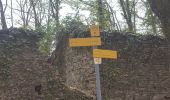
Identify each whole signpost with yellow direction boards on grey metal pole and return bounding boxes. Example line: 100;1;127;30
69;25;117;100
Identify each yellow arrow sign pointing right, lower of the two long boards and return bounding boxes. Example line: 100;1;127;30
93;49;117;59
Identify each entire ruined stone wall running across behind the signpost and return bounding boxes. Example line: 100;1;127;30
0;29;170;100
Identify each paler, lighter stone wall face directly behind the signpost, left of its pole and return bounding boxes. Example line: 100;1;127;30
65;47;95;96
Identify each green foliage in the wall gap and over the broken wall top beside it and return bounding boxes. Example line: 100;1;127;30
39;16;88;54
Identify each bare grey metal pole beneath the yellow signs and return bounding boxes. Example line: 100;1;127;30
95;64;102;100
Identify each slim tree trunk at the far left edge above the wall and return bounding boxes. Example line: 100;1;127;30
0;0;7;29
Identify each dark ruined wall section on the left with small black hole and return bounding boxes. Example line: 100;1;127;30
0;28;93;100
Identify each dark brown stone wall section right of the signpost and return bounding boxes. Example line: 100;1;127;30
102;34;170;100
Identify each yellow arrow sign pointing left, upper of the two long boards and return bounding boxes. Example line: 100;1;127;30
69;37;101;47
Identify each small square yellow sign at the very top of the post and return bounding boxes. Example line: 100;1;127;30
90;25;100;36
